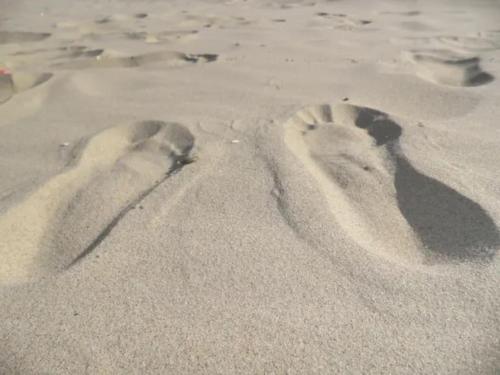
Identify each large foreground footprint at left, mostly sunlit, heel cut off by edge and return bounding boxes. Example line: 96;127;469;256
0;121;194;284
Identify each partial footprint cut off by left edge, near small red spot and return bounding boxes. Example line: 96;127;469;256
0;70;52;104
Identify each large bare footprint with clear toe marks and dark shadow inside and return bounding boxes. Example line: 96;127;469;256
285;104;500;264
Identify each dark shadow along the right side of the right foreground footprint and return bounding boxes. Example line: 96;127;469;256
356;108;500;261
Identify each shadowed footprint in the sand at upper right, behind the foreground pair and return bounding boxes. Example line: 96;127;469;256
406;50;494;87
